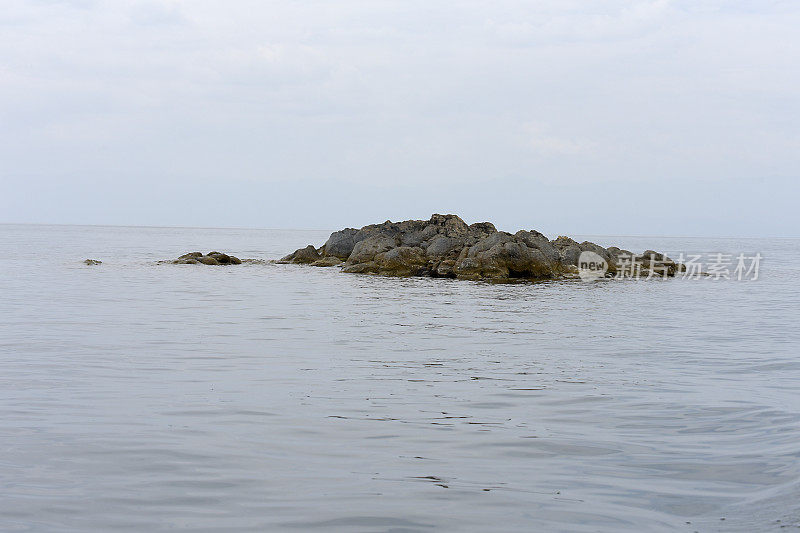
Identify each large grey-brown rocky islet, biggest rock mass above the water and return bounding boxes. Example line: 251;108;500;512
279;215;682;281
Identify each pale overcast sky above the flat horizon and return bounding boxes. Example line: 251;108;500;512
0;0;800;236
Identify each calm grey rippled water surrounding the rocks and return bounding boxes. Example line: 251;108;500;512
0;225;800;532
